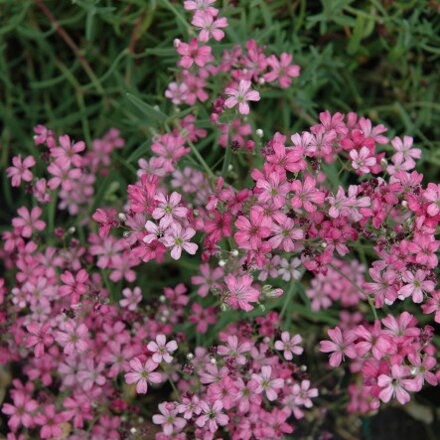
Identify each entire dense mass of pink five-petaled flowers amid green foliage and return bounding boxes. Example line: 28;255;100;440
0;0;440;440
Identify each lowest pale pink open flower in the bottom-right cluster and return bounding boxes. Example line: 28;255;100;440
377;365;420;405
